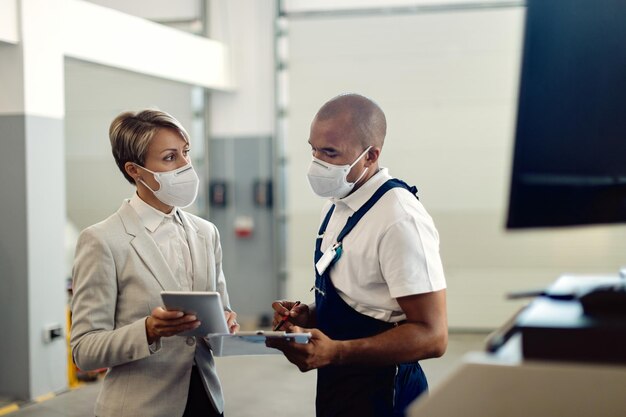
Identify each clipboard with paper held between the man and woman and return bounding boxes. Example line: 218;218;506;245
207;330;311;356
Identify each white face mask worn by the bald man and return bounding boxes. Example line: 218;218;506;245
307;146;371;198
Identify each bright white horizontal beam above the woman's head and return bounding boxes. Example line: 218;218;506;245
62;0;232;89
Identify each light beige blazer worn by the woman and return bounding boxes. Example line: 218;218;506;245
70;201;230;417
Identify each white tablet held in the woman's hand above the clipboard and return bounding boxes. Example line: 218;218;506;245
161;291;228;336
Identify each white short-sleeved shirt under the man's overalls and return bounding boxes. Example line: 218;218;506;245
321;168;446;322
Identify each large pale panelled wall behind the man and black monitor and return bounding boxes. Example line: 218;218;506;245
287;7;626;329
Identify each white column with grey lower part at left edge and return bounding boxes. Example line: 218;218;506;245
0;0;67;400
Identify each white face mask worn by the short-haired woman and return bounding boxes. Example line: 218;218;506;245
138;162;200;207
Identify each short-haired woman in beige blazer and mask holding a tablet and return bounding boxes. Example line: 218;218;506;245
71;110;239;417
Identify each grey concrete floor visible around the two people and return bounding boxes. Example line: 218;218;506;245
0;333;487;417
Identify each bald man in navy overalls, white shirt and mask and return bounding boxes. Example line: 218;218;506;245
267;94;447;417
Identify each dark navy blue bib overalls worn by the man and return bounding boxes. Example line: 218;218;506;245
314;179;428;417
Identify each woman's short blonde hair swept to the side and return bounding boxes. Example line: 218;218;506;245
109;109;189;185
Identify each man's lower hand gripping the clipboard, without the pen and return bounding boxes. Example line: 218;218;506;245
265;326;341;372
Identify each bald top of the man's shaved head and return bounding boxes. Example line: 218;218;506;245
313;94;387;148
